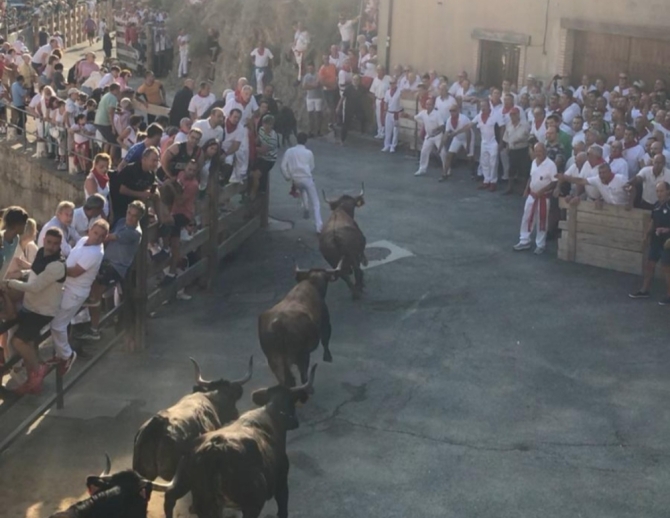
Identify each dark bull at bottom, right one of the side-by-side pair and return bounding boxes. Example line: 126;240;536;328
165;365;316;518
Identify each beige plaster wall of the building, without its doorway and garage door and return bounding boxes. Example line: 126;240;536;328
379;0;670;86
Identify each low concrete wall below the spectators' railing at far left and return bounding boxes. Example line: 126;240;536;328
0;142;84;224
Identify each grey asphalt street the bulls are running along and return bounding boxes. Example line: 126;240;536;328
0;137;670;518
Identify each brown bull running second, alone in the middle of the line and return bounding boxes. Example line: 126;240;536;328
258;265;341;387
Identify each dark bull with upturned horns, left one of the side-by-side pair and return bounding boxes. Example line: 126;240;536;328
133;356;254;480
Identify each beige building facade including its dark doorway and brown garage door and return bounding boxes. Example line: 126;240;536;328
378;0;670;88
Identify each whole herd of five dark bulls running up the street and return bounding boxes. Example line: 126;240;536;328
52;186;367;518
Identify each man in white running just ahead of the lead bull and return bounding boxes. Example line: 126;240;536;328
281;133;323;234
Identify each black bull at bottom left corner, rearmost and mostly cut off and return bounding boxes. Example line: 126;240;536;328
51;455;169;518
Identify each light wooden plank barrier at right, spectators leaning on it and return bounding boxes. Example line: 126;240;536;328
558;199;651;275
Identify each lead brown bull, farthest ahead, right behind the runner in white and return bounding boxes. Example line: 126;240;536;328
319;184;368;299
